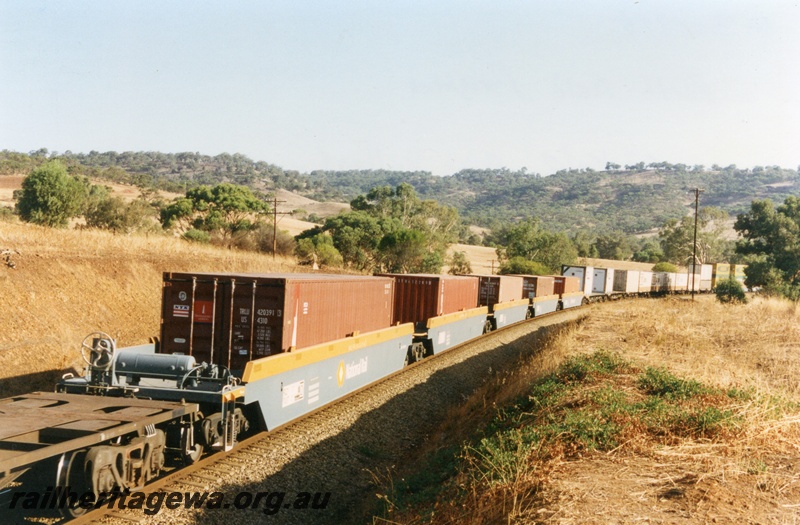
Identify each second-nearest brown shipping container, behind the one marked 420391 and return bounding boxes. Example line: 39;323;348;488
378;273;478;324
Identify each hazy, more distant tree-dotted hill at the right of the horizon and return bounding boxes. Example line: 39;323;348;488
310;163;800;233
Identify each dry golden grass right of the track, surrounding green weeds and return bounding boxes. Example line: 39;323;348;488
378;296;800;524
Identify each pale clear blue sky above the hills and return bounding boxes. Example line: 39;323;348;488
0;0;800;175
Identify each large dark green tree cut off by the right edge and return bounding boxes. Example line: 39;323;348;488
733;197;800;289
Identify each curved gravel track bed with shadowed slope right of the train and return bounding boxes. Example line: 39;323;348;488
51;309;587;525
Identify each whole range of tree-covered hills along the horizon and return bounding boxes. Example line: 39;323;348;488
0;150;800;234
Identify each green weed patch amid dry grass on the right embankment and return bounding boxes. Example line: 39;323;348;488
376;351;746;521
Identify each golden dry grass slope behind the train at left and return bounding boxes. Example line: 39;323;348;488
0;217;307;395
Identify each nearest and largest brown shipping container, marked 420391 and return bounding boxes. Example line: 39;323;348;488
161;273;394;370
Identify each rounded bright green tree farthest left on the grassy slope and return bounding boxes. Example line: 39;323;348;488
17;160;87;228
